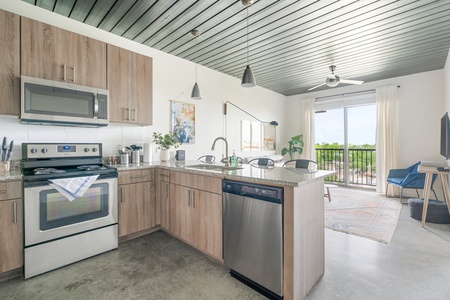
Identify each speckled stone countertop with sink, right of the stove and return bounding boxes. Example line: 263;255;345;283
114;161;336;187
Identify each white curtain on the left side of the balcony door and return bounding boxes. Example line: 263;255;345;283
300;98;316;161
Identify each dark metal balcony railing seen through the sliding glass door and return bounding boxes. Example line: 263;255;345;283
316;148;376;186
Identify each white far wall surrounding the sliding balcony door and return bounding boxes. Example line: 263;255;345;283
283;69;444;167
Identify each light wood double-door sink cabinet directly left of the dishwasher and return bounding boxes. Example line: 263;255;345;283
170;172;222;260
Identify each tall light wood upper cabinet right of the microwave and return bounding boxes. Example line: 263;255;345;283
107;45;153;125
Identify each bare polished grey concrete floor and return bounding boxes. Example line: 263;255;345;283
0;205;450;300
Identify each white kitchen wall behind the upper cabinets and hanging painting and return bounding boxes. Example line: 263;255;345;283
0;0;286;160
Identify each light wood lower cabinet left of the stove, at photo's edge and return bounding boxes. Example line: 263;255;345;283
0;181;23;273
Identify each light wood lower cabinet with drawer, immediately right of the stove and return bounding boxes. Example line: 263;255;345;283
119;169;156;237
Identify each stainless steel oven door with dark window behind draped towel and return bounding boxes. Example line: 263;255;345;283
24;178;118;246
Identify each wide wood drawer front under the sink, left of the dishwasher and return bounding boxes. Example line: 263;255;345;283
170;171;222;194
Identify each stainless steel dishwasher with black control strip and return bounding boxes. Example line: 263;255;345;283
222;180;283;299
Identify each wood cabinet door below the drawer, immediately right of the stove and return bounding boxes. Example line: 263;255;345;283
119;181;155;237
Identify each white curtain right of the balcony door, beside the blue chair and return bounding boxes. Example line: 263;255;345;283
376;85;398;194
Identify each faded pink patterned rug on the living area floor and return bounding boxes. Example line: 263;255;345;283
324;187;402;244
